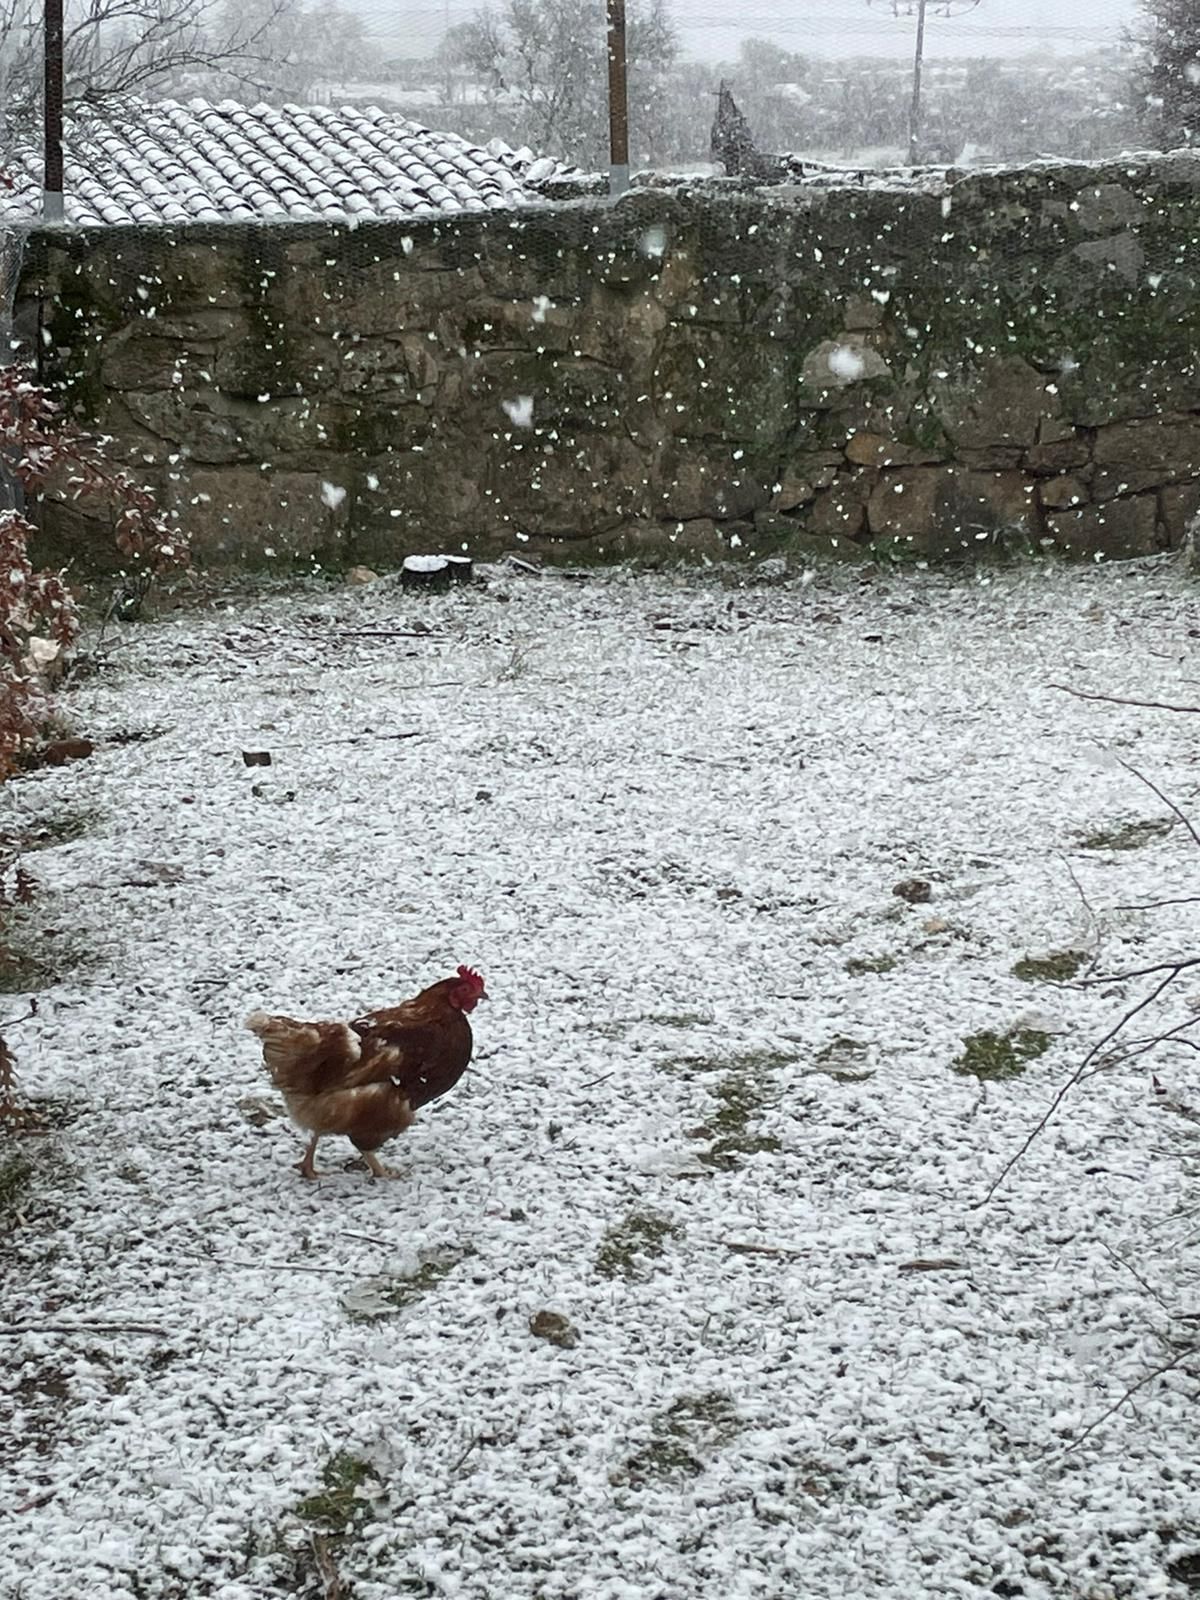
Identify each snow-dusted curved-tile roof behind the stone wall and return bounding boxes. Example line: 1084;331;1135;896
0;99;558;227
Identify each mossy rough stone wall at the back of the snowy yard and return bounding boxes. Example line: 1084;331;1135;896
19;155;1200;563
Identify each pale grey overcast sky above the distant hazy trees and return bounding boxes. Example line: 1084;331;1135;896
347;0;1138;59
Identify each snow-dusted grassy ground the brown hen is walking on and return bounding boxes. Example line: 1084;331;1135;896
0;562;1200;1600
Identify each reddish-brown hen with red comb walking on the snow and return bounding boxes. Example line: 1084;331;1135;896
246;966;488;1178
